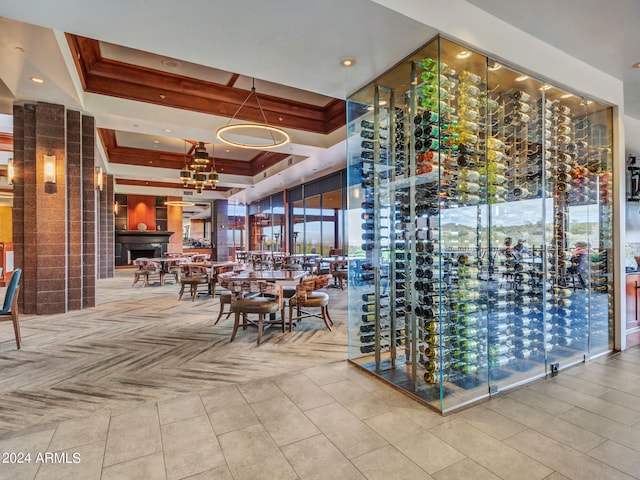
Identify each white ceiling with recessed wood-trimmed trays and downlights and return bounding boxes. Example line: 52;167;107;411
0;0;640;202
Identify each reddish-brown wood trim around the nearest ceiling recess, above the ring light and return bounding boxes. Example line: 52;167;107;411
67;34;346;135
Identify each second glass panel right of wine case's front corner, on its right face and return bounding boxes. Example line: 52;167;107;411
486;61;551;391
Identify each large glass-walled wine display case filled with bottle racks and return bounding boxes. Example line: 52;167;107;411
347;37;613;412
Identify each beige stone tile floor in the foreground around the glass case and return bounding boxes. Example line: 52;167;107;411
0;347;640;480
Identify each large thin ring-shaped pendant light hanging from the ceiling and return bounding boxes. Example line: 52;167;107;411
216;78;290;150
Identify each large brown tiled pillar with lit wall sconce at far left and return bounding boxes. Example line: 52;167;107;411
13;103;95;314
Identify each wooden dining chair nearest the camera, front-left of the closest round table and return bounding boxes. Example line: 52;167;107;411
229;280;285;345
